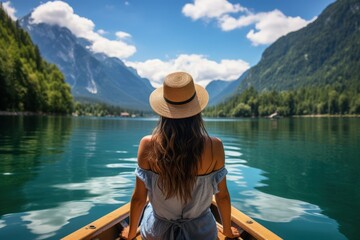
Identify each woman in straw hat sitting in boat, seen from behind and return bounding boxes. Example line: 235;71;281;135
122;72;239;239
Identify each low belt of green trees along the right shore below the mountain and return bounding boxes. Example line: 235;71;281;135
205;85;360;117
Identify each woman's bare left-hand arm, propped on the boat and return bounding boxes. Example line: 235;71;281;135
122;136;151;239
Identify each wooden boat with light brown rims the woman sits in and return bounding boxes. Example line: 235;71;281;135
62;199;281;240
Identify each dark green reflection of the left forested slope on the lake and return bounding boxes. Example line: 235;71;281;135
0;116;72;216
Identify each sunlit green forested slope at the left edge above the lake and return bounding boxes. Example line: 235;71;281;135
0;5;73;113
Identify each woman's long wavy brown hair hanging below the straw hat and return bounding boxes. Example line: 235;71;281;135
150;113;209;203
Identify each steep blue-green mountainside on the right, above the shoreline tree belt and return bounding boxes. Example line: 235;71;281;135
240;0;360;91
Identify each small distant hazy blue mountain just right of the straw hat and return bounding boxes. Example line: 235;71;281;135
206;71;247;106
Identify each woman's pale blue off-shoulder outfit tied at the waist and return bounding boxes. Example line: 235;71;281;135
135;167;227;240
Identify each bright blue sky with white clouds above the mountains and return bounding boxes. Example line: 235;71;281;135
3;0;334;86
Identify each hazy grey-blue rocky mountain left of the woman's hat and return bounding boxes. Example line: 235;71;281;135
19;14;153;110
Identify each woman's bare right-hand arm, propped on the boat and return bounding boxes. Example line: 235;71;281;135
214;139;239;238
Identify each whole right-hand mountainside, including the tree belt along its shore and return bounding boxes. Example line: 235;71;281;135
207;0;360;116
